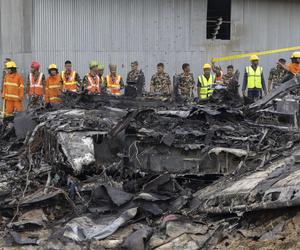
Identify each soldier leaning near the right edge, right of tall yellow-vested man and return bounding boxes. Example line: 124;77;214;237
268;58;288;92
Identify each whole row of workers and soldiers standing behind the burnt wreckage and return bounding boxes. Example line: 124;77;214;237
2;52;300;117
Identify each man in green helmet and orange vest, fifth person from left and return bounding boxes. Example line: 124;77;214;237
83;61;101;94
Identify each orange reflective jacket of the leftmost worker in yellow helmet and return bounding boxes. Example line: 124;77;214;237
2;73;24;101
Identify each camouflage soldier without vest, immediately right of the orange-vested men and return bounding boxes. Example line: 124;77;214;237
126;61;145;96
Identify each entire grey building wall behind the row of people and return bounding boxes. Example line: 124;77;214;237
0;0;300;90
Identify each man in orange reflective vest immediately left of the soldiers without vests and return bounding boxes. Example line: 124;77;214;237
105;64;124;96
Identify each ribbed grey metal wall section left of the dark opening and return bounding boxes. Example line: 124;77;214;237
33;0;205;87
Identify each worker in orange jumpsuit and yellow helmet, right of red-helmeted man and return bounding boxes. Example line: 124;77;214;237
45;64;62;106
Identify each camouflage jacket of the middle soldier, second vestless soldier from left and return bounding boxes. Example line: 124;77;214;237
150;72;171;95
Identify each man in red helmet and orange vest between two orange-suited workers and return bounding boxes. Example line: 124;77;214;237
27;61;45;108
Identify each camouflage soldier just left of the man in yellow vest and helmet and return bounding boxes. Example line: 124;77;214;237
174;63;195;99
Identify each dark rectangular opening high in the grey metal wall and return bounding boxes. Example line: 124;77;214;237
206;0;231;40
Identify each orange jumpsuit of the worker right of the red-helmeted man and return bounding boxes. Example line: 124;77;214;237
45;74;62;103
